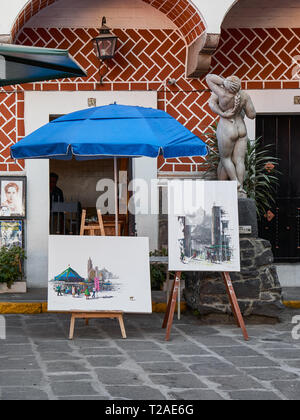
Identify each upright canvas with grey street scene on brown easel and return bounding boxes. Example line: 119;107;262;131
168;180;240;272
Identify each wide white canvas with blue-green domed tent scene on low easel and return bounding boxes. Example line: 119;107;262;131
48;235;152;313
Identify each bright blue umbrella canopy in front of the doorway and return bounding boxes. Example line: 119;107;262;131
11;104;207;160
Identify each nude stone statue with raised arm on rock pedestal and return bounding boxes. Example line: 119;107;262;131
206;74;256;197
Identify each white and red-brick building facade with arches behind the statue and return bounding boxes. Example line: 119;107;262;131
0;0;300;287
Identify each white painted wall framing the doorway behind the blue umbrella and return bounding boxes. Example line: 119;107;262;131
25;92;158;288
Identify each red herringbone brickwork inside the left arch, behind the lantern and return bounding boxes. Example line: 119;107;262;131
17;28;186;85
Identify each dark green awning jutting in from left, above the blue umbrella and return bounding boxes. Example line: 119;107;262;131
0;44;87;86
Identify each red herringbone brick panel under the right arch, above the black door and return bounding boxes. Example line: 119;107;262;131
212;28;300;89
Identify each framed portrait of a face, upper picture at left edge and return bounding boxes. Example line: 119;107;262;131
0;176;26;219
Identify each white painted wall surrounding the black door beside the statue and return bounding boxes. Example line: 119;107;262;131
246;90;300;287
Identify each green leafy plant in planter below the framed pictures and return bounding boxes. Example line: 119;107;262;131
0;246;25;288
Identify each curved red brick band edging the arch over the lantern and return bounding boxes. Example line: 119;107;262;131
11;0;205;45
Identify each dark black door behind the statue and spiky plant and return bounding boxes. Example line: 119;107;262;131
256;115;300;262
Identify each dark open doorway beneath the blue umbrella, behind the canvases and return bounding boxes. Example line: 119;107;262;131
49;115;135;236
